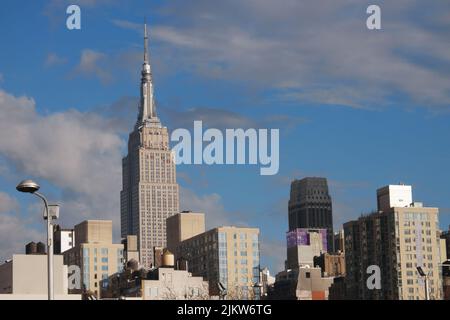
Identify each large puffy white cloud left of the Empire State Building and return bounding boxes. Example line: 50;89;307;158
0;91;124;238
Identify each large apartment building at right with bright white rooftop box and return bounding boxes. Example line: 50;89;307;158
344;186;446;300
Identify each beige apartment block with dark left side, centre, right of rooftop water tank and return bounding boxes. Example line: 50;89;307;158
176;226;260;299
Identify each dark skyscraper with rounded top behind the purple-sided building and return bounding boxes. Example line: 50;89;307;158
289;177;334;252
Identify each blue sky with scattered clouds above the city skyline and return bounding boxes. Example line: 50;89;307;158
0;0;450;273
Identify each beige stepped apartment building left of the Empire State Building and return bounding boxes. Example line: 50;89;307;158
64;220;124;297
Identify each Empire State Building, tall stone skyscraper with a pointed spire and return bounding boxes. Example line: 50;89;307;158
120;25;179;268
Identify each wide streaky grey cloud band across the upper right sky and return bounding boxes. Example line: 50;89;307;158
110;0;450;110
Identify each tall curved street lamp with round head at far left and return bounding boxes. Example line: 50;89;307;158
16;180;54;300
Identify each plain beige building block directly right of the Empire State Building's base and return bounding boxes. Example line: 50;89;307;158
166;211;205;258
